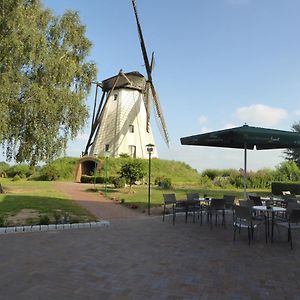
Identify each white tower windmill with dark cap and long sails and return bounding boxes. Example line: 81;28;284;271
83;0;169;158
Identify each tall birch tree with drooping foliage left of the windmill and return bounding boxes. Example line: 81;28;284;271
0;0;96;165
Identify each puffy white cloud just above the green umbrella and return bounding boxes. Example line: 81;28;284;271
235;104;288;126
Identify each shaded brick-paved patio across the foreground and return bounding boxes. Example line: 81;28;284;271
0;212;300;300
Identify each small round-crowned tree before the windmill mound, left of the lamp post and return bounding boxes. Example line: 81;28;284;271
119;159;145;192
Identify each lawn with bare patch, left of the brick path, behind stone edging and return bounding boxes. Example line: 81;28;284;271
0;179;95;225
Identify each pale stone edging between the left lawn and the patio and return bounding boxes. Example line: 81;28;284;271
0;221;110;234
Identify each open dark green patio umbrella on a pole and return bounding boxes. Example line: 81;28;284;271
180;125;300;198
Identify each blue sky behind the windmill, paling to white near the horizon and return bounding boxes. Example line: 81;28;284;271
43;0;300;171
